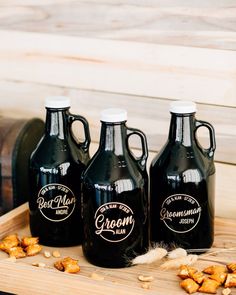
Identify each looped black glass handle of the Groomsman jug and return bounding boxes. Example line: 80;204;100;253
195;120;216;158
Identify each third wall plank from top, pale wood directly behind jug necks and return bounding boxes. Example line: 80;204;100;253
0;80;236;164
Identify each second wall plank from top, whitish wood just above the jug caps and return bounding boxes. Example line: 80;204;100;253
0;30;236;107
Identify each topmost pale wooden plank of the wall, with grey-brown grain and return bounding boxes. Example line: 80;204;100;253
0;0;236;50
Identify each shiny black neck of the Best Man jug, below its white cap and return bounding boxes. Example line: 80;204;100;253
45;108;69;139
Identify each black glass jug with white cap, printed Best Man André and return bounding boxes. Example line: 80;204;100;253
29;96;90;247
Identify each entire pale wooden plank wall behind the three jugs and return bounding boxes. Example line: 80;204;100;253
0;0;236;218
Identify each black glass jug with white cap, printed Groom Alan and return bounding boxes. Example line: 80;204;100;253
82;109;148;268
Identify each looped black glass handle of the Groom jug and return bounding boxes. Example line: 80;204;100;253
127;127;148;171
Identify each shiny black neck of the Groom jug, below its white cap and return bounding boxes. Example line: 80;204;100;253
99;122;126;155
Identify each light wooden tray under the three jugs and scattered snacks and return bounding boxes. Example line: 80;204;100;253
0;204;236;295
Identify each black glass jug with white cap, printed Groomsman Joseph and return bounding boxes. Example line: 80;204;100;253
150;101;216;250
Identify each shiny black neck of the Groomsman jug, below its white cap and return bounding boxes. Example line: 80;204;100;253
169;113;195;146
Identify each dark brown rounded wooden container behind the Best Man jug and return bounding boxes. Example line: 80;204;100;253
0;117;44;215
